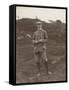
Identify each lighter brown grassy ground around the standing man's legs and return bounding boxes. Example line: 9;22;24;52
16;38;66;83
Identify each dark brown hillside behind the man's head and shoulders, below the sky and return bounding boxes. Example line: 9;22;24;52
16;18;65;43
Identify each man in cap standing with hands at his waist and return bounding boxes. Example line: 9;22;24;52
33;21;49;76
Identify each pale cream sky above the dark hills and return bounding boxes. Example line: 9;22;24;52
16;6;66;23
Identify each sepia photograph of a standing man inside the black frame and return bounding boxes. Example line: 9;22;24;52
16;6;67;84
